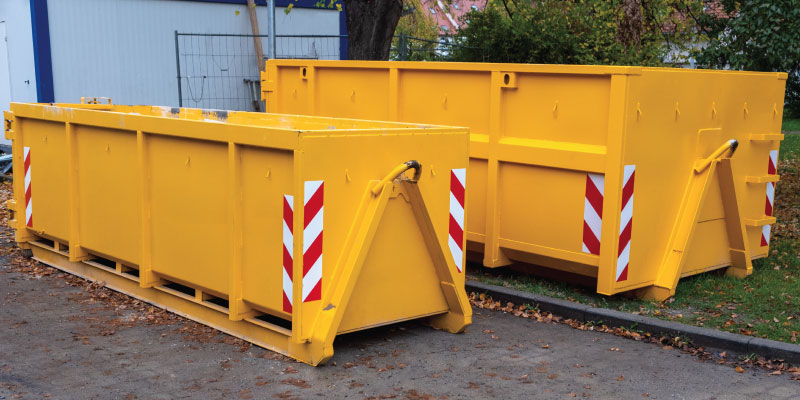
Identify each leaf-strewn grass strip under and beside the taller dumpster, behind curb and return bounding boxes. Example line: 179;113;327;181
469;134;800;343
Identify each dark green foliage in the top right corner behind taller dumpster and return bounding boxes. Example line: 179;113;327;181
697;0;800;117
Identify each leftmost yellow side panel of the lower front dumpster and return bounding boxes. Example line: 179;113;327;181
17;118;69;243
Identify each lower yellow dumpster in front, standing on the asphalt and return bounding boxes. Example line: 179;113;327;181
5;103;471;365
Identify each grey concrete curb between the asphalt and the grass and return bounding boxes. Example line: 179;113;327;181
466;281;800;364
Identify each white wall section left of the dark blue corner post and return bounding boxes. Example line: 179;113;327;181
0;0;36;106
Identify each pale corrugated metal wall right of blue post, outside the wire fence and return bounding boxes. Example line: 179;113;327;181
48;0;339;106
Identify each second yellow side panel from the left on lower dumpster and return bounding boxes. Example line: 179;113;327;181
72;125;142;265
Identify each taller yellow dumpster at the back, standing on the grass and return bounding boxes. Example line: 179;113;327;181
261;60;786;299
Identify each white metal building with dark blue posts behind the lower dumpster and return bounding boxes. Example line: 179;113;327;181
0;0;347;134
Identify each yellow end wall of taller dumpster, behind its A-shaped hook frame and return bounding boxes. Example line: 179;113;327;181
622;69;785;286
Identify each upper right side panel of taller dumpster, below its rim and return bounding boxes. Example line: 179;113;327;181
500;73;611;147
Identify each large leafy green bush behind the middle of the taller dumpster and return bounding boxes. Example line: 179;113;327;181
453;0;699;65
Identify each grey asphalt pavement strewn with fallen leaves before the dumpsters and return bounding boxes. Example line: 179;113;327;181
0;263;800;399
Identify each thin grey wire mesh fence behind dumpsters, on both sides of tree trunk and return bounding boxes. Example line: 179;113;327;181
175;31;476;111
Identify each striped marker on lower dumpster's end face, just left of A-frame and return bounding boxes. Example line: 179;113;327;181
303;181;325;303
